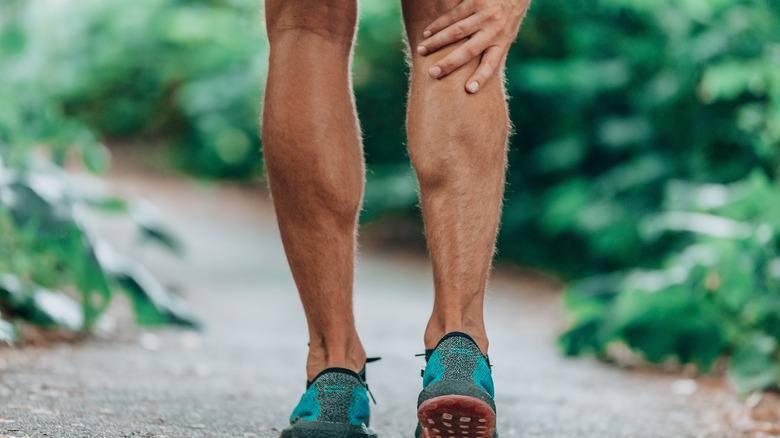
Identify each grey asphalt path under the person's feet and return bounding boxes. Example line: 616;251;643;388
0;161;762;438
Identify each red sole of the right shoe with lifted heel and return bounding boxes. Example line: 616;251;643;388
417;395;496;438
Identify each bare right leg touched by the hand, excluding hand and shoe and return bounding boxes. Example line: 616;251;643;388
403;0;509;353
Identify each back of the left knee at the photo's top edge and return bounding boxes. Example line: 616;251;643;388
266;0;357;48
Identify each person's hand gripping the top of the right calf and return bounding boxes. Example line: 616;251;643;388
417;0;531;93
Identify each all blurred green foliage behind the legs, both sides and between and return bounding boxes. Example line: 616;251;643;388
0;0;780;404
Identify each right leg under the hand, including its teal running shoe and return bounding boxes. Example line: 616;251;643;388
403;4;509;438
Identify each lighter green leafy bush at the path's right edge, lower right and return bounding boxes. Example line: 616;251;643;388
561;171;780;392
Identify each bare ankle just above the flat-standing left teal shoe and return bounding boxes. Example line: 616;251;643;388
306;333;366;381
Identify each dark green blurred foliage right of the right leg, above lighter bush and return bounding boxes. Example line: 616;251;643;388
500;0;780;275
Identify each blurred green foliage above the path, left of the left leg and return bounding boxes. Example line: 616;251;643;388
6;0;267;178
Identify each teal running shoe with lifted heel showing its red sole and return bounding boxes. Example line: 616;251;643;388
415;332;498;438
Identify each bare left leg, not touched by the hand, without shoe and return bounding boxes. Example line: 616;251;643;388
262;0;365;380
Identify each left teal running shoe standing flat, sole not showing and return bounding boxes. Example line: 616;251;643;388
281;368;376;438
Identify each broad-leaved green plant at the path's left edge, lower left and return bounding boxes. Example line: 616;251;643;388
0;159;197;340
